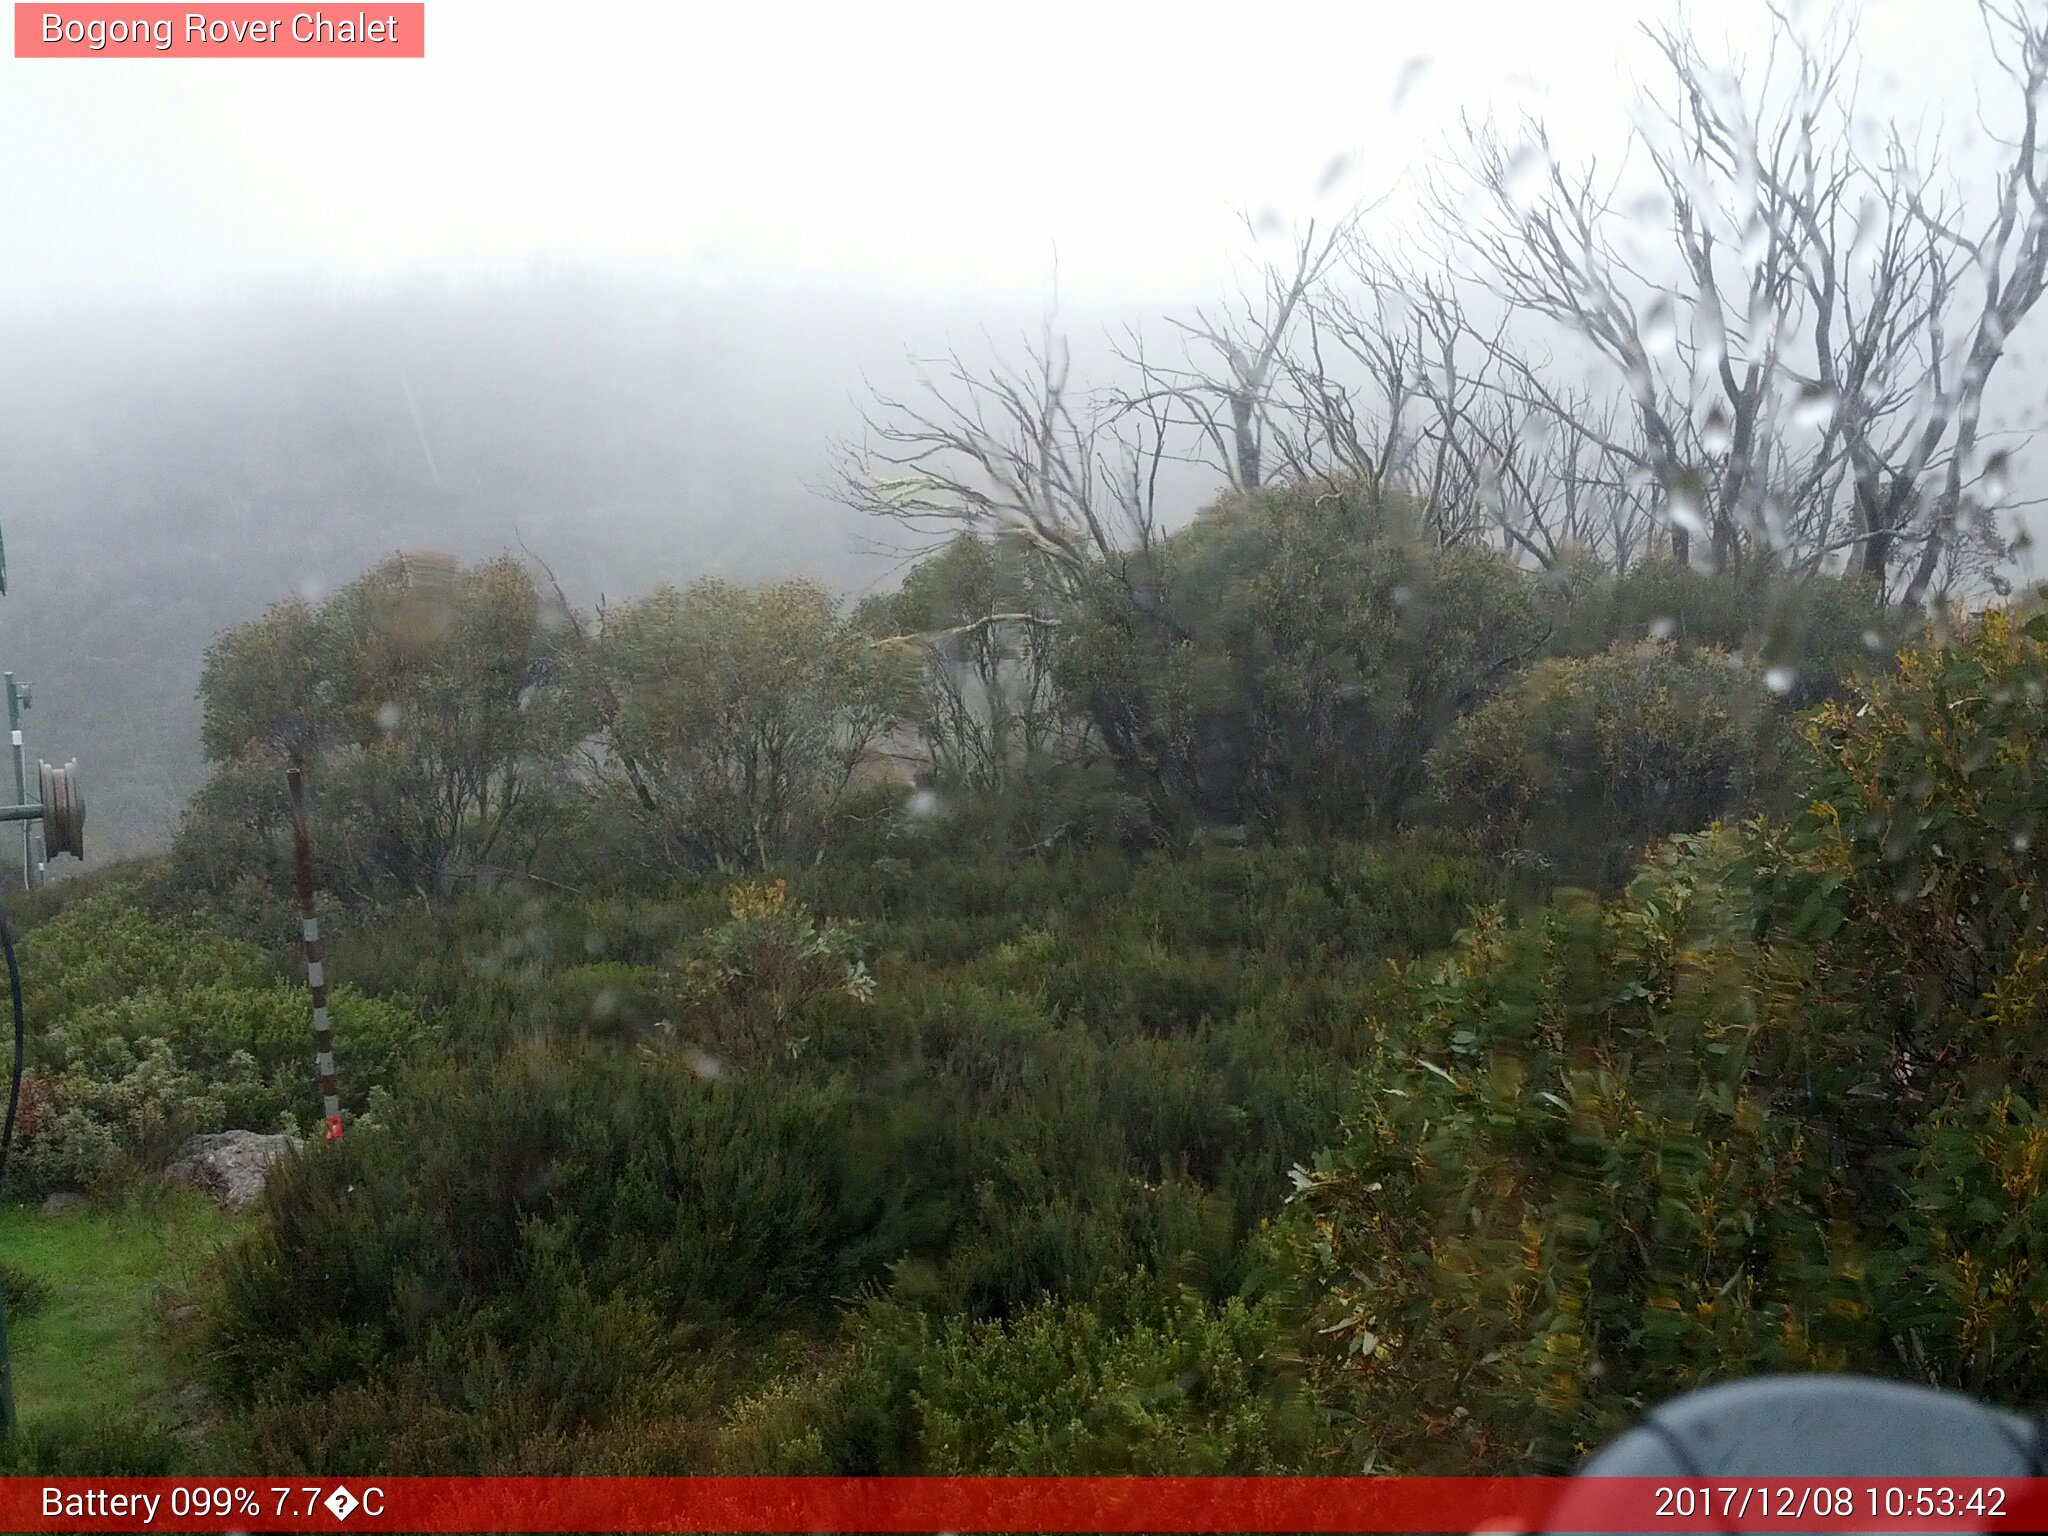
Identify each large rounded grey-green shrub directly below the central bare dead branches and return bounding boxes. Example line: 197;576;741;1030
1167;483;1546;838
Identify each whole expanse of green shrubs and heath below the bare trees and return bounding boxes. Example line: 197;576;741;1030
12;456;2048;1475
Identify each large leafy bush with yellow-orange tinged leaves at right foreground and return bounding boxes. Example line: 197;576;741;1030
1282;612;2048;1470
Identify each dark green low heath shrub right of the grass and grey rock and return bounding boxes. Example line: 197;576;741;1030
201;1044;937;1464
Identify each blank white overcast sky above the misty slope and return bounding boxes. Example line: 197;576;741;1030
0;0;2007;309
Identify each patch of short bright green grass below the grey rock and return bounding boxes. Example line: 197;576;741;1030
0;1190;238;1440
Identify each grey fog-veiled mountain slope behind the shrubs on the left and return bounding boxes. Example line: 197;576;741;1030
0;281;991;860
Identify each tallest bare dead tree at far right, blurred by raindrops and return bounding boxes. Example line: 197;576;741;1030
1438;0;2048;604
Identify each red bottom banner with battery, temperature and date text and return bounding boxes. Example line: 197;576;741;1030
12;1477;2048;1536
